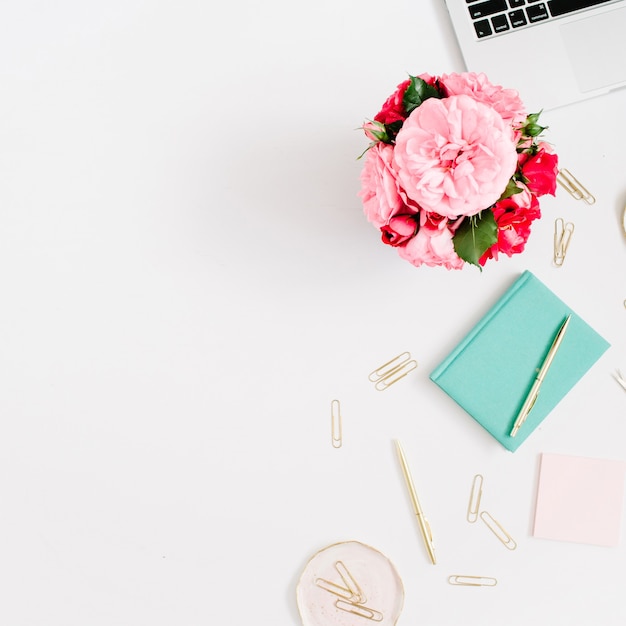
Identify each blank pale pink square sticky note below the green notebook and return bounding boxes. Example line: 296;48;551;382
533;454;626;546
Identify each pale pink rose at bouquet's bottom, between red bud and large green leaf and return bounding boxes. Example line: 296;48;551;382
397;212;465;270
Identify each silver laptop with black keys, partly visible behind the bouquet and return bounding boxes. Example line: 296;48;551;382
445;0;626;112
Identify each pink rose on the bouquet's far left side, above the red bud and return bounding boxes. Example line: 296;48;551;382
359;143;414;228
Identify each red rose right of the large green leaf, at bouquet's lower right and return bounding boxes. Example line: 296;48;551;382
478;195;541;265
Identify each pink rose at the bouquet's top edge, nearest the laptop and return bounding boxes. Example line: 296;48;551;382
440;72;526;126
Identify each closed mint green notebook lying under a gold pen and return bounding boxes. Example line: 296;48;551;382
430;271;609;451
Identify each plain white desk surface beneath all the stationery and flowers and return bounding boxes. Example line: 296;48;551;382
0;0;626;626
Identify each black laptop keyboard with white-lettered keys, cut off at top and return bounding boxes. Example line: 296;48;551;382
466;0;615;39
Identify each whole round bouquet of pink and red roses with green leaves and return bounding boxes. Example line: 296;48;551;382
359;73;558;269
